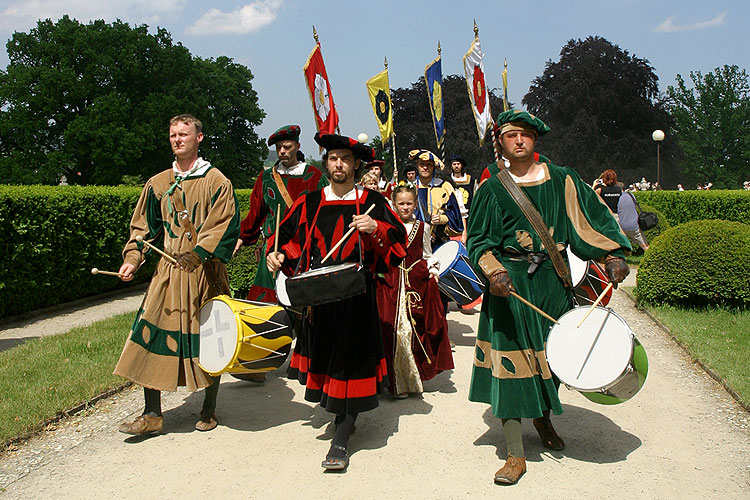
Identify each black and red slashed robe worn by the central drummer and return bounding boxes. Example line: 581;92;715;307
279;187;405;414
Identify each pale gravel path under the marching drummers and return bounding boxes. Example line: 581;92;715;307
0;280;750;500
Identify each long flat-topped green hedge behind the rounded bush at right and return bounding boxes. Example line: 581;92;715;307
635;190;750;226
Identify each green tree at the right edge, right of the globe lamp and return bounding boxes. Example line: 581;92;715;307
667;65;750;188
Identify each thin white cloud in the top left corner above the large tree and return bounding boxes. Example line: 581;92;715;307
0;0;186;30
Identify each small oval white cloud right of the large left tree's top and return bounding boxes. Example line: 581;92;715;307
188;0;281;35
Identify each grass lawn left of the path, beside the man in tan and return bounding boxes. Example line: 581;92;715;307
0;312;135;443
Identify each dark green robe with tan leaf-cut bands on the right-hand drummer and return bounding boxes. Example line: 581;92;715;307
467;163;630;418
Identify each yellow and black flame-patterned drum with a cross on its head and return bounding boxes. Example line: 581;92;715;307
198;295;292;375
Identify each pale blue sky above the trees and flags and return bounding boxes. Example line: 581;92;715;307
0;0;750;156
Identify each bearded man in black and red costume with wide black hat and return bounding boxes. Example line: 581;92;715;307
266;133;406;470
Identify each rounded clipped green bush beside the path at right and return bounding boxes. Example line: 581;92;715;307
635;220;750;308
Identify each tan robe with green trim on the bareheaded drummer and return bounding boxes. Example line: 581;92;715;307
114;159;240;391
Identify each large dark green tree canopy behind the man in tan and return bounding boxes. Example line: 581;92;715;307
0;16;267;187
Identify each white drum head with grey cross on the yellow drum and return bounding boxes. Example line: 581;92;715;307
198;299;238;374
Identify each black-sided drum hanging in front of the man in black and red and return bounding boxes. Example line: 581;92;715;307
284;262;367;307
